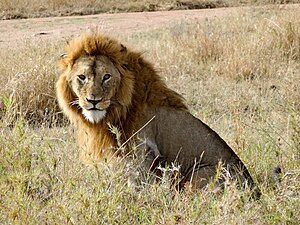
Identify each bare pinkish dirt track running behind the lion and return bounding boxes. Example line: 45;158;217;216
0;8;245;49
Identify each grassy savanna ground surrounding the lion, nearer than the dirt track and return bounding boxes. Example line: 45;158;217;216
0;0;300;224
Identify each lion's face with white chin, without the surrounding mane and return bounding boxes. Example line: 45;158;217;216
69;56;121;123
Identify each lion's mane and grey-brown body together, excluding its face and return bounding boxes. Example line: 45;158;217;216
56;32;253;195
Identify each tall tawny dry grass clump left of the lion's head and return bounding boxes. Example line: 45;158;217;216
0;43;62;126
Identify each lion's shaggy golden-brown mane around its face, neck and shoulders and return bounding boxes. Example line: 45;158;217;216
56;32;187;158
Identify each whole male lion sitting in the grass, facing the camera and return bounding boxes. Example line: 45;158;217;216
56;32;260;195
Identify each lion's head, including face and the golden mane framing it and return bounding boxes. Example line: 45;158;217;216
57;32;133;124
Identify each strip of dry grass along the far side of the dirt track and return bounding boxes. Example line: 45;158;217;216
0;0;299;19
